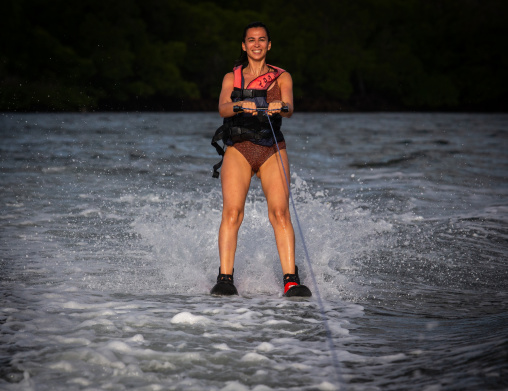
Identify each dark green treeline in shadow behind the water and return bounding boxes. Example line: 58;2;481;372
0;0;508;111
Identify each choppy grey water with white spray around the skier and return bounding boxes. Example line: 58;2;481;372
0;113;508;391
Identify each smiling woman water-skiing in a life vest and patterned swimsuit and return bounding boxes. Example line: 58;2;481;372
211;22;310;296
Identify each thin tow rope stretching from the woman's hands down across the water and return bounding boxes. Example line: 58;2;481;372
265;110;343;384
